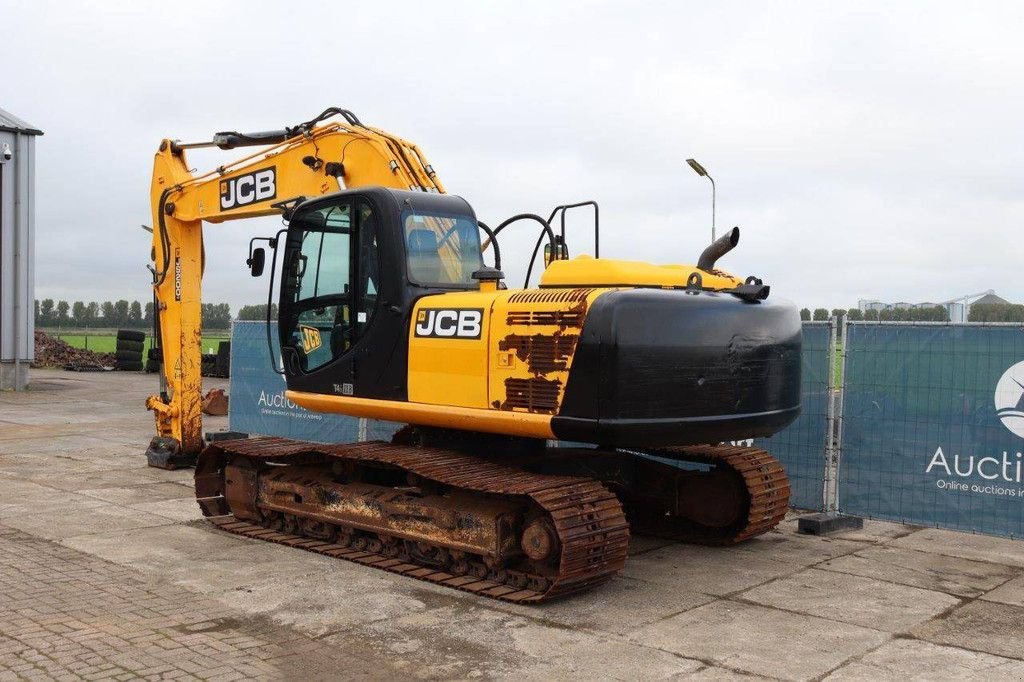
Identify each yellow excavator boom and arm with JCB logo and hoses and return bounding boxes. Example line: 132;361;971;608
145;109;444;468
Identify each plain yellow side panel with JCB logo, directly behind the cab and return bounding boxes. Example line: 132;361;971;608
409;292;500;408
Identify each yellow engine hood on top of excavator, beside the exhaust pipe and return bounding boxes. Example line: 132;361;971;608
541;256;743;289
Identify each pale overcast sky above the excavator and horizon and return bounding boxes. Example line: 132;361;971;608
0;0;1024;309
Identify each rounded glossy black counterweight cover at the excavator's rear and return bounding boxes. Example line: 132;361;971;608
551;289;801;446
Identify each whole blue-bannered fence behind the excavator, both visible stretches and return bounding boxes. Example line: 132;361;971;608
230;321;1024;538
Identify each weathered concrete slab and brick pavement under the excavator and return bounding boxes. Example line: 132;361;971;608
0;370;1024;680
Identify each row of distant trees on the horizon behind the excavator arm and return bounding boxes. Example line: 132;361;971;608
36;298;234;329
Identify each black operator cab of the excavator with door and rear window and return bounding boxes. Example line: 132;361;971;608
279;187;483;399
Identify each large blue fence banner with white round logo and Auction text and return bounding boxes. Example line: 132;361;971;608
840;324;1024;538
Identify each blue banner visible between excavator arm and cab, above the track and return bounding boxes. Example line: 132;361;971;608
228;322;400;442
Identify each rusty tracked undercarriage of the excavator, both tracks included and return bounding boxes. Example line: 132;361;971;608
196;427;790;603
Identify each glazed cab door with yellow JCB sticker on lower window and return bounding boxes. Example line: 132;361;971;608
280;197;380;395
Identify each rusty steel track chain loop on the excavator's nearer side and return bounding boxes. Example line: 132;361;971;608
196;437;630;603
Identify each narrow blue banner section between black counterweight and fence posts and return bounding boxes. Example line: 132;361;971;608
754;323;831;509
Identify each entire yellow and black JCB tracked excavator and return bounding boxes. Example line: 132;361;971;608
146;108;801;604
